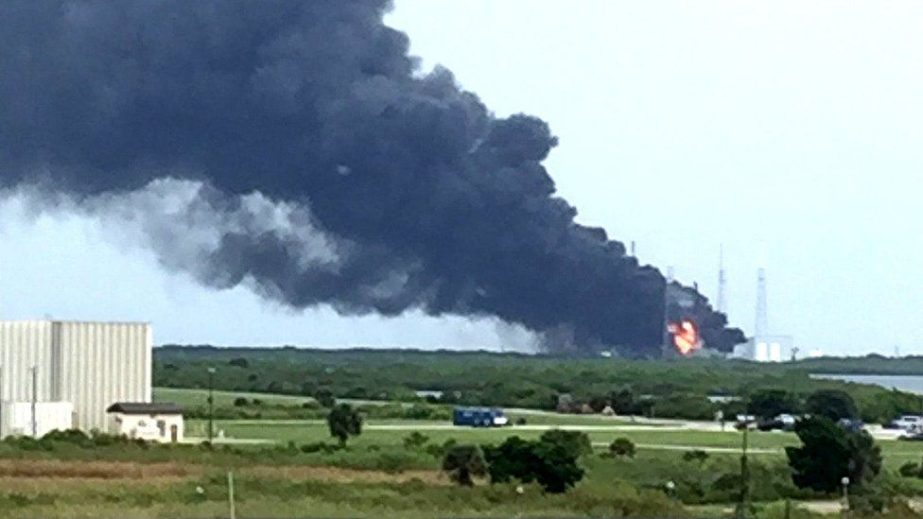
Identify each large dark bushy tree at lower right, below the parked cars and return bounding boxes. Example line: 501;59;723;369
785;417;881;493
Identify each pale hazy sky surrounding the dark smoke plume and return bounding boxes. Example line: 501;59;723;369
0;0;923;355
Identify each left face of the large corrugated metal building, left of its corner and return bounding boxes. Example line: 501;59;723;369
0;321;55;402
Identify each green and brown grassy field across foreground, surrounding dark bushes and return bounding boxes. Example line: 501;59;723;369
0;389;923;519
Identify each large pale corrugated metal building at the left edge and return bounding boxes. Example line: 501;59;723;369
0;320;153;437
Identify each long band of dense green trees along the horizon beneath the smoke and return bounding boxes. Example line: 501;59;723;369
154;346;923;422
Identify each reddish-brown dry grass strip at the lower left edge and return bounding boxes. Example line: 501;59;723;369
0;460;202;479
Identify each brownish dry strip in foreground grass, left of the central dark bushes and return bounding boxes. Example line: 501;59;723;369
241;466;451;485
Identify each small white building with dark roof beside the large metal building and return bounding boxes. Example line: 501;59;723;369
106;402;184;443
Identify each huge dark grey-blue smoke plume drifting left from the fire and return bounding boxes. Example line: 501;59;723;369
0;0;742;355
